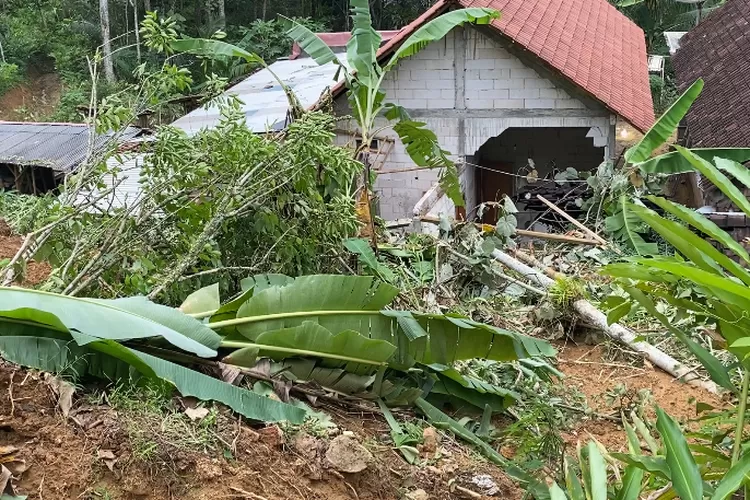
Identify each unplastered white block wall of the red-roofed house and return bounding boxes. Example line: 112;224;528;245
335;28;609;220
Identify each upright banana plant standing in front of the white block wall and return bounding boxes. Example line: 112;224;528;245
287;0;500;206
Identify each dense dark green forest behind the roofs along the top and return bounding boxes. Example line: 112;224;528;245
0;0;722;121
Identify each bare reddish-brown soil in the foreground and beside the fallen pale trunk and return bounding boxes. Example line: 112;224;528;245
0;344;722;500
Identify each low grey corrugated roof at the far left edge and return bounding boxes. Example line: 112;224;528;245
0;122;140;173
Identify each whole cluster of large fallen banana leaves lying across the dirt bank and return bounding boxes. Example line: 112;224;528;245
0;275;555;422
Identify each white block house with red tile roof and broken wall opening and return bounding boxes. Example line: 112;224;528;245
334;0;654;224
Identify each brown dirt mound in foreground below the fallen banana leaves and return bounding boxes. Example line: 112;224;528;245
0;361;522;500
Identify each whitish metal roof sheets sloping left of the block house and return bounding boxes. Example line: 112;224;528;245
172;58;343;135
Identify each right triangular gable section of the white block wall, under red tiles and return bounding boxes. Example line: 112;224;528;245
465;29;585;109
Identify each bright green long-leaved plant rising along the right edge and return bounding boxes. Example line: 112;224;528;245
603;146;750;496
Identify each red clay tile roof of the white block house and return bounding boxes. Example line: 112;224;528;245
335;0;656;131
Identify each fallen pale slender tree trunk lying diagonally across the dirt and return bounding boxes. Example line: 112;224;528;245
492;250;719;394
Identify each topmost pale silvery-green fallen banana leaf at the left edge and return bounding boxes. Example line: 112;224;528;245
0;287;220;357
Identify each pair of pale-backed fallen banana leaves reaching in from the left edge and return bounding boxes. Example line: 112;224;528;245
0;288;305;423
